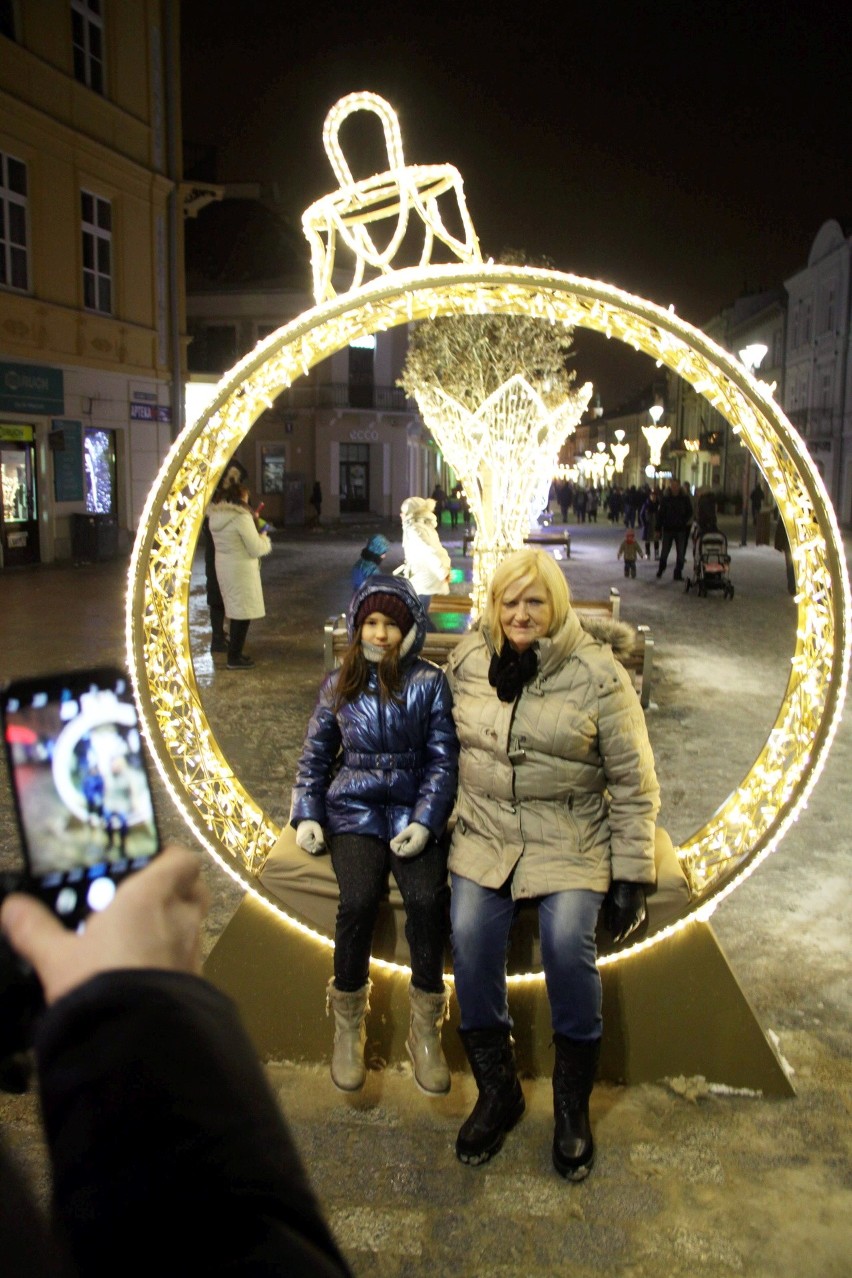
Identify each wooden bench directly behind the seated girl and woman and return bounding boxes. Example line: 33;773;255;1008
323;587;654;709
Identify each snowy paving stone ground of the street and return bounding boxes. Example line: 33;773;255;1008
0;520;852;1278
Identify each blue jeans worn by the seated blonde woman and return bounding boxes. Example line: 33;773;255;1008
450;874;604;1040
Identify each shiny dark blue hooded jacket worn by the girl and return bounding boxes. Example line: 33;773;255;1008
290;574;459;842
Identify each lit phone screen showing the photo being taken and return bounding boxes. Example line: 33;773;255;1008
3;668;160;928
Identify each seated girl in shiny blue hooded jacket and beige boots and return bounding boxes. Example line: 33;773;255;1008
290;573;459;1095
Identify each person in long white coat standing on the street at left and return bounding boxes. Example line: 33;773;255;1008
208;479;272;670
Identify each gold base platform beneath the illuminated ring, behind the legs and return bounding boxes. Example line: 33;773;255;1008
204;896;796;1097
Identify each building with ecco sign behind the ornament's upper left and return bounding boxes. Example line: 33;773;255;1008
186;187;451;527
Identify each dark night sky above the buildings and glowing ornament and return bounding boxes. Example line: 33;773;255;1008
181;0;852;406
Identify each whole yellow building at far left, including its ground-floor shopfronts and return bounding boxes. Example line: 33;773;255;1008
0;0;185;567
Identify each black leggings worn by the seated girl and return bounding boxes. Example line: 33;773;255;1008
328;835;450;994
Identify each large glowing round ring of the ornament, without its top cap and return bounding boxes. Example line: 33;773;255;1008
126;263;849;980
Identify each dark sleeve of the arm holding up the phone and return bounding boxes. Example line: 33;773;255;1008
36;970;350;1275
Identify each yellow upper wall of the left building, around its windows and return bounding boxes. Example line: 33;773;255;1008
0;0;185;377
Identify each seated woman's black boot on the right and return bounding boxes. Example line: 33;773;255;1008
553;1034;600;1181
